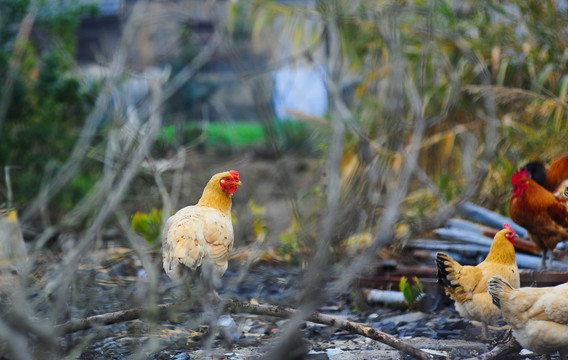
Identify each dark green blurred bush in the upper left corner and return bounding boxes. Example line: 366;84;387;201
0;1;95;208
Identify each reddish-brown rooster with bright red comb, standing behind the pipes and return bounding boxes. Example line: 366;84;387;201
509;169;568;269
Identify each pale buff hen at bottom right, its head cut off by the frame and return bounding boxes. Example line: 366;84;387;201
487;276;568;359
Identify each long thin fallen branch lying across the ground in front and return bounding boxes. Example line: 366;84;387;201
55;299;433;360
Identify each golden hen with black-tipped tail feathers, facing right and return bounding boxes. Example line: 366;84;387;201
436;224;520;339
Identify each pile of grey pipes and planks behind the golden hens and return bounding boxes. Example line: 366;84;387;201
360;202;568;303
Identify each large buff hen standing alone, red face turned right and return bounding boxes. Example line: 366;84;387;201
162;170;242;288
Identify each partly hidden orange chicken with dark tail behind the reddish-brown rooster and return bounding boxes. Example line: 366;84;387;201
523;154;568;193
